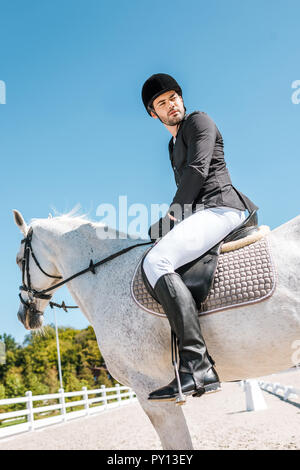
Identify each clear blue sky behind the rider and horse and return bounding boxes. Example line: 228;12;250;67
0;0;300;342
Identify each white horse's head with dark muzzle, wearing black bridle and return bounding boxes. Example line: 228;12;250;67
13;210;61;330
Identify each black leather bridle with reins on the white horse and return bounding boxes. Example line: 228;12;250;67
19;227;153;315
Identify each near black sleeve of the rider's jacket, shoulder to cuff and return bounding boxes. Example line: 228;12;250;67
169;112;217;212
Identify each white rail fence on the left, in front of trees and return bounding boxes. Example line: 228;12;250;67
0;385;136;438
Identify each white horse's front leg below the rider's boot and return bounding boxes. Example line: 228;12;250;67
135;390;193;450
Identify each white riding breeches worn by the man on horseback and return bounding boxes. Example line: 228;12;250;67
143;206;246;287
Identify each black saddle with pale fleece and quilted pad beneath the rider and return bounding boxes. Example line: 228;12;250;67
131;210;275;313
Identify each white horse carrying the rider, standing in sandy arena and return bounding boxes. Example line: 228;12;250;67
14;211;300;450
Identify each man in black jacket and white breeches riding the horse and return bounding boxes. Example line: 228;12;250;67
142;73;258;401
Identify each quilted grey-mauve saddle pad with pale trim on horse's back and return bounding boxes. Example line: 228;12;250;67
131;236;276;317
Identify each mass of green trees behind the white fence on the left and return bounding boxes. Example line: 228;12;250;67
0;325;114;406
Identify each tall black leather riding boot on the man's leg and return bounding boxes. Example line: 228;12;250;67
148;273;220;401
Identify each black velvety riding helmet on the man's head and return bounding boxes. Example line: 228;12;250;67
142;73;182;116
